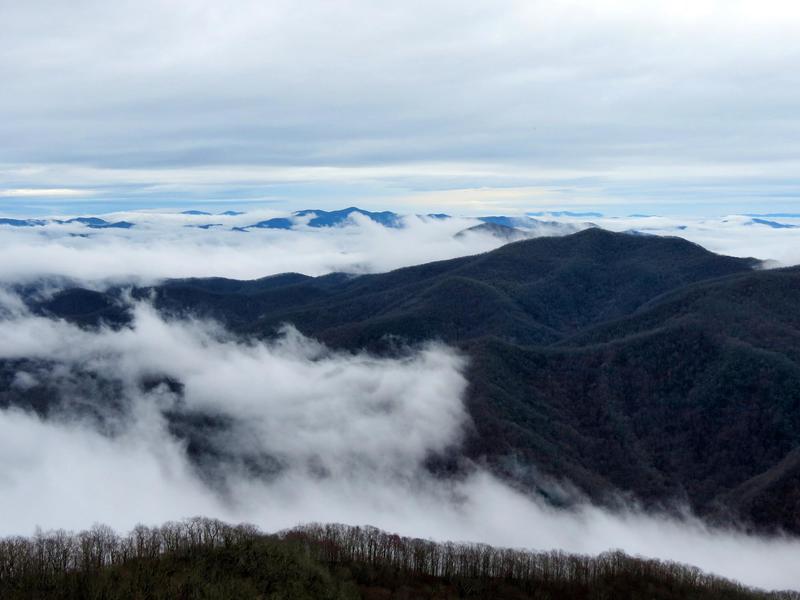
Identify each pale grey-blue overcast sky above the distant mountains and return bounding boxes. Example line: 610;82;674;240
0;0;800;214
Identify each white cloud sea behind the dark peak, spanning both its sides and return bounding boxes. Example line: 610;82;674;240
0;211;800;286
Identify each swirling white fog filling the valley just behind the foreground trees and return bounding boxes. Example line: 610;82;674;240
0;293;800;588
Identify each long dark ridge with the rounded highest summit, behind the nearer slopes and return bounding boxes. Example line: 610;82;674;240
39;229;755;348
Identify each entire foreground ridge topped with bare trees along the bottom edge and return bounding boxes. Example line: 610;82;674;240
0;517;800;600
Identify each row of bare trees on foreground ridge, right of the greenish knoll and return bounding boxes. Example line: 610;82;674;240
288;524;800;600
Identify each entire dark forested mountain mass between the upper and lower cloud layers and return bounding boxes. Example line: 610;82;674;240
15;224;800;533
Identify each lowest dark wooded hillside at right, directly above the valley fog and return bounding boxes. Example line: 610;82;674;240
460;326;800;531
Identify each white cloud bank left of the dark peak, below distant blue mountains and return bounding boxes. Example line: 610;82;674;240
0;213;510;283
